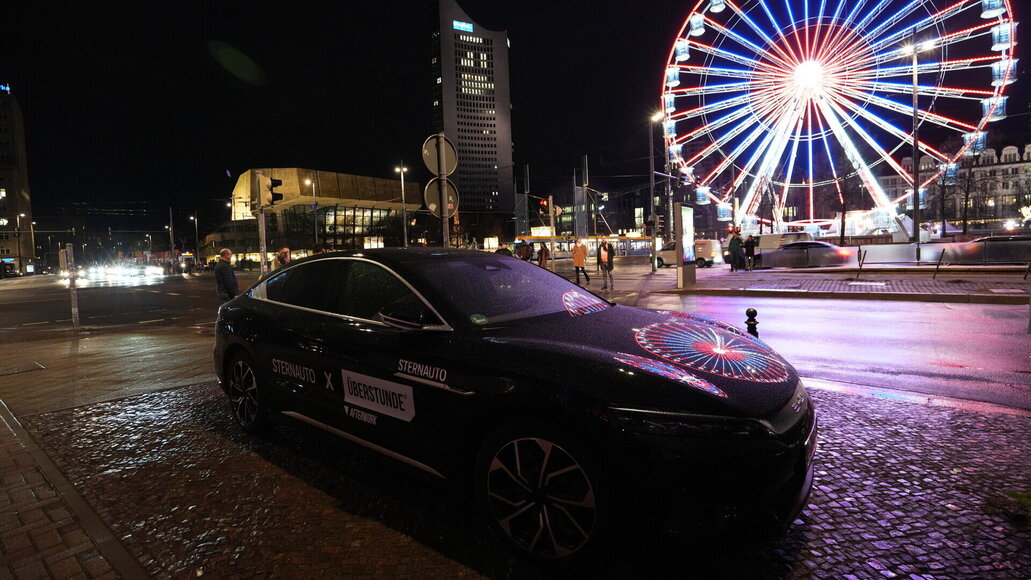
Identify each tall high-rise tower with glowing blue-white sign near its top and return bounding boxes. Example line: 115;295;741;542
431;0;514;237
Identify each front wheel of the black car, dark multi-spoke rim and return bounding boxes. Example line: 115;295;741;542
475;419;612;566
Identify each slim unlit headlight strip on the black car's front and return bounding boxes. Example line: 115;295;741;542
608;407;773;439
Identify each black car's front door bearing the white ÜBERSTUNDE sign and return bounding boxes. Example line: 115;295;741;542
301;258;467;473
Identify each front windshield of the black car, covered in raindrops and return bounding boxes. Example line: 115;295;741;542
408;253;610;326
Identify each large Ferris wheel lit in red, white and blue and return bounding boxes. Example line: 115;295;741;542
662;0;1017;230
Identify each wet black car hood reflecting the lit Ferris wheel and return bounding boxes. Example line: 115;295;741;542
485;306;798;417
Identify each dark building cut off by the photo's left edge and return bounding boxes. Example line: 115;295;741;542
0;84;36;275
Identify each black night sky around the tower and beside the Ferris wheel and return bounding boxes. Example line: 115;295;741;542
0;0;1028;231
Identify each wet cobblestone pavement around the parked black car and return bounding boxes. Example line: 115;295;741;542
6;382;1031;579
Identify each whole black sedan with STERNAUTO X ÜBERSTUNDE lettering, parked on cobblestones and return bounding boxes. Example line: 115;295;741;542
214;248;817;561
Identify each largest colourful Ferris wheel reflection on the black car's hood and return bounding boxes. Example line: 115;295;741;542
635;321;791;382
